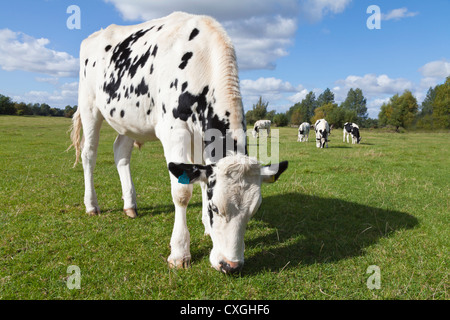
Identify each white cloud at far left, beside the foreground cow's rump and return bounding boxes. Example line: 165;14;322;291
0;29;79;77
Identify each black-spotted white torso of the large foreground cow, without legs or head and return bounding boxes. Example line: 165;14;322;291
79;12;245;142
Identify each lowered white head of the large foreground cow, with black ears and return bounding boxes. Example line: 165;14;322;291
169;155;288;273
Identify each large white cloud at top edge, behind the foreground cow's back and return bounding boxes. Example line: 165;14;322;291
104;0;351;70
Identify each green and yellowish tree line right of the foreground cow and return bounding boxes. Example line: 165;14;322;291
246;77;450;131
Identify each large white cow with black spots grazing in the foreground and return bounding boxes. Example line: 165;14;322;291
71;12;287;273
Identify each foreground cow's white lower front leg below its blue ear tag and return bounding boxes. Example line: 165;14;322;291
167;178;192;268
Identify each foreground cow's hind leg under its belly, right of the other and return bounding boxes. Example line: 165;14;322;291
114;135;137;218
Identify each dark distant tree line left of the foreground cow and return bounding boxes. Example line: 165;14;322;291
0;94;77;118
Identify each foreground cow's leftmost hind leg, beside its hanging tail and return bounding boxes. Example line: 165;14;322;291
80;106;103;215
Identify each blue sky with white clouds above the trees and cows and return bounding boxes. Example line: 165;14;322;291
0;0;450;118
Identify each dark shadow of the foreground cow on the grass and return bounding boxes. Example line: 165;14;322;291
242;193;418;275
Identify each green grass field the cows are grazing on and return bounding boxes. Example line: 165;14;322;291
0;116;450;299
